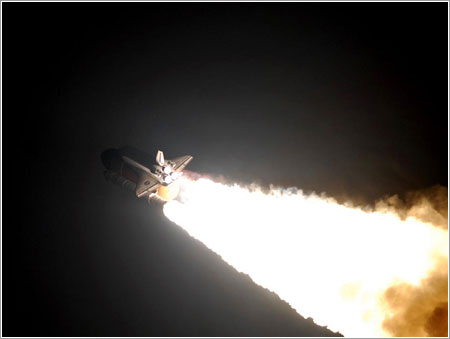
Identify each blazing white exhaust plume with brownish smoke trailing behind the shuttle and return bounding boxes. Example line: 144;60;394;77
164;177;448;337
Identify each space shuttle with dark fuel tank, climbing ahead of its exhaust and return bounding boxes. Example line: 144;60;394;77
102;149;193;201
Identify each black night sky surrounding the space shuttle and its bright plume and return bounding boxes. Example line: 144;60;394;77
2;2;448;336
